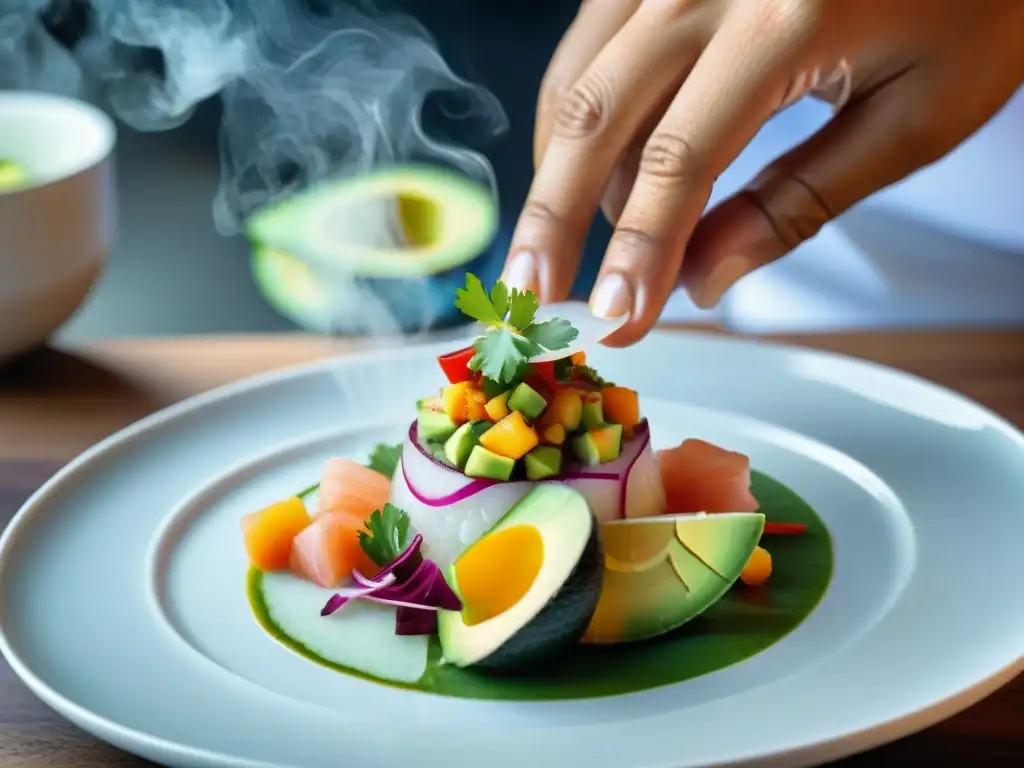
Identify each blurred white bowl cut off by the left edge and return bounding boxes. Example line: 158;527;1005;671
0;91;117;360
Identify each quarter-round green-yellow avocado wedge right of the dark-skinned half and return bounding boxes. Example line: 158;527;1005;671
583;512;765;644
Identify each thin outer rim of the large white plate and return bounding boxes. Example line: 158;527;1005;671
0;329;1024;768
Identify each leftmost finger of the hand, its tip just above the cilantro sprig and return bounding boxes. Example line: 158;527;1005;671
505;3;712;302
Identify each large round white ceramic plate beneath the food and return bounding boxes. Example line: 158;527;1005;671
0;334;1024;768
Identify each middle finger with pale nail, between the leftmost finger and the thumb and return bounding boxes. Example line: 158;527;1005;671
591;3;815;346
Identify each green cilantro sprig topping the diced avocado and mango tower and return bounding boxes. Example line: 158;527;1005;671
455;272;579;384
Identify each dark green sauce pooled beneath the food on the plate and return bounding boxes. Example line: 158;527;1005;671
248;472;833;700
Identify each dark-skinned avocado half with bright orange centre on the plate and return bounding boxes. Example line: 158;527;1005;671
437;483;603;672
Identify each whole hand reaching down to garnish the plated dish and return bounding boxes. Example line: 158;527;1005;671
505;0;1024;346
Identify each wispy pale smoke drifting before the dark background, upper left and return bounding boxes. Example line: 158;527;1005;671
0;0;506;234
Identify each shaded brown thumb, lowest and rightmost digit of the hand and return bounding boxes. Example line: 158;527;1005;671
680;71;966;308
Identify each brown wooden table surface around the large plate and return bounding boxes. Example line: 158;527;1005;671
0;330;1024;768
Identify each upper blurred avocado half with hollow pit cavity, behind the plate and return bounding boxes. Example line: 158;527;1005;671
246;166;498;280
